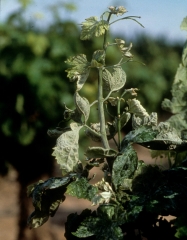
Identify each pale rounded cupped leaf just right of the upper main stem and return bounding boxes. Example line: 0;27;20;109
103;67;126;92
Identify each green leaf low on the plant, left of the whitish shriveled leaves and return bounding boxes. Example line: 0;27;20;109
66;177;98;201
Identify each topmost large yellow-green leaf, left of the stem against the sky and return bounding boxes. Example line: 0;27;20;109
80;17;109;40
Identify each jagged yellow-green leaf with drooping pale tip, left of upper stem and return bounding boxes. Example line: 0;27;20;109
65;54;90;91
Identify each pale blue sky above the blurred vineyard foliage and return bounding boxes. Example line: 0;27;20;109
0;0;187;43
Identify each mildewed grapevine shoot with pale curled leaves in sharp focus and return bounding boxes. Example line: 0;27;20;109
28;7;187;239
